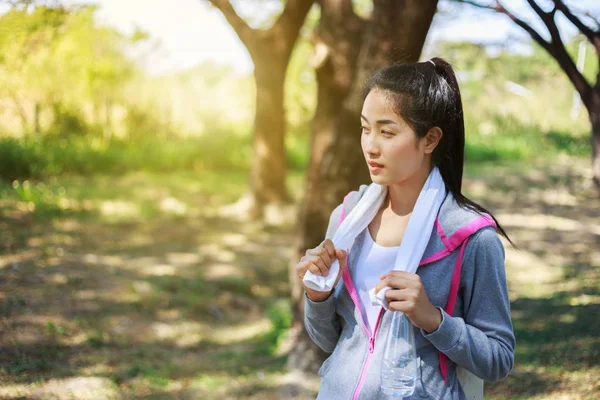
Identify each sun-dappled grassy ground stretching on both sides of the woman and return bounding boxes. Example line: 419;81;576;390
0;159;600;399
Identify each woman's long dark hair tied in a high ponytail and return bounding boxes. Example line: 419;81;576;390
363;57;515;246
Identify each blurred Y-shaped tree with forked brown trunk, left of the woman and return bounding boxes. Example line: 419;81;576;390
209;0;314;218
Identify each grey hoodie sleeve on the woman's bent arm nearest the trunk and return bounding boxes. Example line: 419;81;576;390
304;204;342;353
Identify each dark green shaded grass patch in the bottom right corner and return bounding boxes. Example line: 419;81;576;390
486;287;600;399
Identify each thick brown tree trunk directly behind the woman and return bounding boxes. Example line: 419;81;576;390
288;0;437;372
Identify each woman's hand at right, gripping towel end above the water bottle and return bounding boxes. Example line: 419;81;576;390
375;271;442;333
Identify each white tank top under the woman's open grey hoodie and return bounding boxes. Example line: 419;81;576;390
351;227;400;333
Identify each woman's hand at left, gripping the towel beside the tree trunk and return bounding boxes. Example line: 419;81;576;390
296;239;348;302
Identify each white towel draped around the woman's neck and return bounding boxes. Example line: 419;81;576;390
303;168;446;309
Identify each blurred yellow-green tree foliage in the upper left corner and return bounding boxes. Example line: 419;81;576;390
0;2;145;140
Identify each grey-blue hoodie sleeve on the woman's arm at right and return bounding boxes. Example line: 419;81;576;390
421;228;515;382
